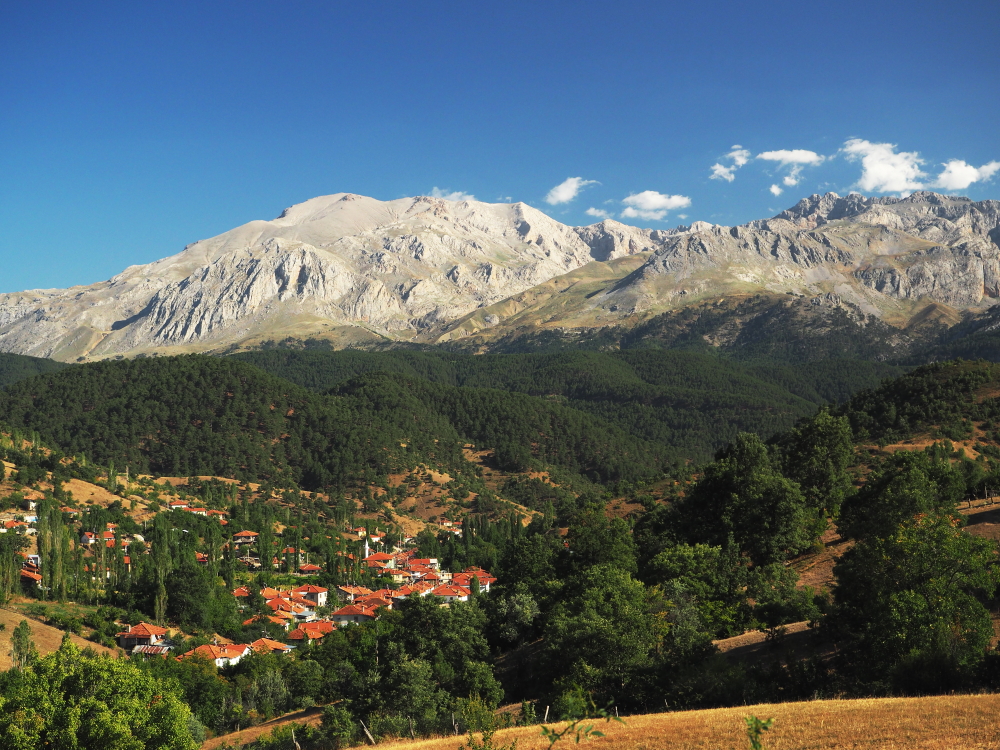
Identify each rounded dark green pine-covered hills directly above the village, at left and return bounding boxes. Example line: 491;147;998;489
0;355;671;489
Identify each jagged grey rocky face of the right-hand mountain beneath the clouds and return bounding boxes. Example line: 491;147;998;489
595;193;1000;315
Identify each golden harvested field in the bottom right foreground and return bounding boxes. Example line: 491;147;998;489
383;695;1000;750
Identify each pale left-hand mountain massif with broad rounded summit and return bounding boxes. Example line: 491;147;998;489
0;193;664;360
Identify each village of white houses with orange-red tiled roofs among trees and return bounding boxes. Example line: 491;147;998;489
0;484;496;668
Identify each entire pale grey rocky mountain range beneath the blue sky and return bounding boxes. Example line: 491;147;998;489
0;193;1000;361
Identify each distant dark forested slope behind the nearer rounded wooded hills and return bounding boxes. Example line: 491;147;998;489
233;349;902;460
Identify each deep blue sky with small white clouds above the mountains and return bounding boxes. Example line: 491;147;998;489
0;0;1000;292
